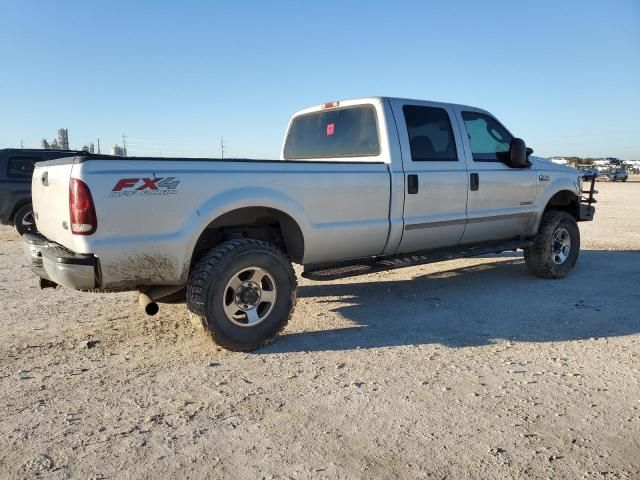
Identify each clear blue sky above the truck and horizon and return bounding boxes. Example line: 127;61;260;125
0;0;640;159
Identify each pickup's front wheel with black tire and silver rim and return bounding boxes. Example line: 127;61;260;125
524;210;580;278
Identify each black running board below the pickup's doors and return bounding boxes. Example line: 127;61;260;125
302;240;533;282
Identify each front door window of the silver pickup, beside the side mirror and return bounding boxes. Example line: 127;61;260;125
462;112;513;162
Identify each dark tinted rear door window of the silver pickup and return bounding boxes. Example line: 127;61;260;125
402;105;458;162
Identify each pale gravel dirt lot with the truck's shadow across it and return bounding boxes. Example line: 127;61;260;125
0;182;640;479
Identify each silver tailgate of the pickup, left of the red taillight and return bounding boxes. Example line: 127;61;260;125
31;157;74;249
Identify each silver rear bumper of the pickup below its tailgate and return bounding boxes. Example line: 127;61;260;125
23;234;98;290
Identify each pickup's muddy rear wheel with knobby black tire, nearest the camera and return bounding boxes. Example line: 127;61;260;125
186;239;297;352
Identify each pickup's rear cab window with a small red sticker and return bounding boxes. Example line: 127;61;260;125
284;106;380;160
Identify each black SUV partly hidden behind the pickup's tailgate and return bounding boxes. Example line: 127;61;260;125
0;148;86;235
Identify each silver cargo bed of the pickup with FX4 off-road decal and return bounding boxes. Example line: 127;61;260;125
33;155;391;288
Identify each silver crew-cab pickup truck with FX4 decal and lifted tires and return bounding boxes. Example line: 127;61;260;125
24;97;594;350
